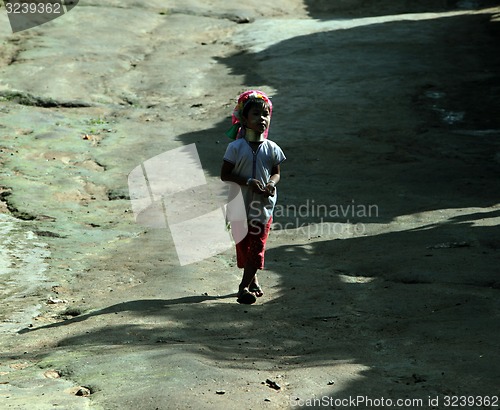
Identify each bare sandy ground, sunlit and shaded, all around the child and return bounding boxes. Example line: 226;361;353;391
0;0;500;410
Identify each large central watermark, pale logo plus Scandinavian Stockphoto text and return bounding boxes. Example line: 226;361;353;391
128;144;379;266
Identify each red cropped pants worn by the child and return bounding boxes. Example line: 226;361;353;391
236;218;273;269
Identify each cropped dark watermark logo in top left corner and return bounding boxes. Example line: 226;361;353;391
4;0;78;33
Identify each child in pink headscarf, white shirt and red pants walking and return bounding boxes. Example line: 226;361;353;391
221;90;285;304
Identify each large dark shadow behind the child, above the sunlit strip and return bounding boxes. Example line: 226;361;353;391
188;14;500;223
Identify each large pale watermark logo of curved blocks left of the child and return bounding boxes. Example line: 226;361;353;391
128;144;248;266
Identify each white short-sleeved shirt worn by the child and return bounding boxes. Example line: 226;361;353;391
224;138;286;224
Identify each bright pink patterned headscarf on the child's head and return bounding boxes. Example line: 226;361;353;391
226;90;273;139
